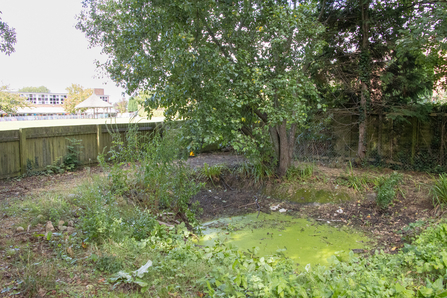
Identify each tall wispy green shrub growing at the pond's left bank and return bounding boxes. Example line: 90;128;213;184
99;125;202;224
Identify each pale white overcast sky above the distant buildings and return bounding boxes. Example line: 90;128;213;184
0;0;127;102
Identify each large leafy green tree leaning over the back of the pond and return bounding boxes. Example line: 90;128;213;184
77;0;323;175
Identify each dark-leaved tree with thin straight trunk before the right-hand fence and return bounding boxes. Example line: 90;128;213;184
314;0;433;159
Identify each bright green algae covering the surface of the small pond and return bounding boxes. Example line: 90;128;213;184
198;213;368;268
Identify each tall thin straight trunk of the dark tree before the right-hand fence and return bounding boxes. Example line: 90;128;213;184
357;0;370;160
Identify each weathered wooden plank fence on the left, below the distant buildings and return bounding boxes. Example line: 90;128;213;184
0;122;161;179
